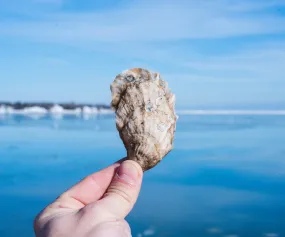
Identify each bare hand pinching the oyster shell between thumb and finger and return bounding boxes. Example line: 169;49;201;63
34;160;143;237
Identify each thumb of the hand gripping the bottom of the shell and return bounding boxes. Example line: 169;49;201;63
96;160;143;219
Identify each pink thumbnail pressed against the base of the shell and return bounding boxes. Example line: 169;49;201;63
117;161;139;185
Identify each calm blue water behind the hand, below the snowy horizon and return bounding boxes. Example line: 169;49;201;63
0;115;285;237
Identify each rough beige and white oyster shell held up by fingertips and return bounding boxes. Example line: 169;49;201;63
111;68;177;171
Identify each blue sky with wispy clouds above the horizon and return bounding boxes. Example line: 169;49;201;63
0;0;285;107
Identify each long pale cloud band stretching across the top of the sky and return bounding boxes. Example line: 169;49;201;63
0;0;285;43
